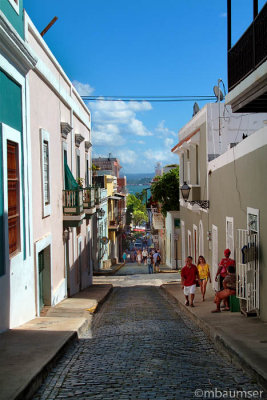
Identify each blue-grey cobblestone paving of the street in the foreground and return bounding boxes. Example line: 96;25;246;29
34;287;265;400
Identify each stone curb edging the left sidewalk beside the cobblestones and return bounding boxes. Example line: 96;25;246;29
14;287;113;400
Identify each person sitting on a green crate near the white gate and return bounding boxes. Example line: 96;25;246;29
212;265;236;313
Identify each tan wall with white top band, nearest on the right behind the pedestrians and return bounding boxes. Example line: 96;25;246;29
209;128;267;321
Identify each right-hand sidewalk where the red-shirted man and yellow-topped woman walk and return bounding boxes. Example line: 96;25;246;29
161;284;267;390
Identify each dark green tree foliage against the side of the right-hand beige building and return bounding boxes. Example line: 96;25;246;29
151;167;180;216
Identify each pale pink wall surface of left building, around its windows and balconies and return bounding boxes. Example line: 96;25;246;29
26;15;92;306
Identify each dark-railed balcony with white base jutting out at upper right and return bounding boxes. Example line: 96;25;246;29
226;3;267;112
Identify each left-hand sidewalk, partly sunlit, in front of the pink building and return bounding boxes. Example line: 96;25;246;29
0;284;112;400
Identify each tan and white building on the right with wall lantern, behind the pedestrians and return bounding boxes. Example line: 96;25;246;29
172;103;267;320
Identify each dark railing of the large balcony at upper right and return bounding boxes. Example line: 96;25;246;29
228;3;267;91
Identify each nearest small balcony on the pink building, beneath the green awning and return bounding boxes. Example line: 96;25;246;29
63;189;85;227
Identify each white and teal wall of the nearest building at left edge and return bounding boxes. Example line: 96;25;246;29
0;0;35;331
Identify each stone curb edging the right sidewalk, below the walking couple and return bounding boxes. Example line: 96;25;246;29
160;285;267;390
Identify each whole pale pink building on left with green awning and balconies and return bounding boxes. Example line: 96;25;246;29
25;14;95;315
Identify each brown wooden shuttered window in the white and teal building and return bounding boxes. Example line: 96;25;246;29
7;140;20;255
